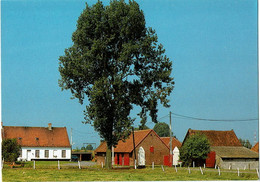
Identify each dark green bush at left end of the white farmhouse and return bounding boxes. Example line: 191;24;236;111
2;138;21;162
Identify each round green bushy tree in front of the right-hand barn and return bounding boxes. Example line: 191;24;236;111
180;133;210;166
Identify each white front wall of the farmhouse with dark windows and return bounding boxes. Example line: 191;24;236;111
18;147;71;161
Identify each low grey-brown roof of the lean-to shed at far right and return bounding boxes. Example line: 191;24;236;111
210;146;259;159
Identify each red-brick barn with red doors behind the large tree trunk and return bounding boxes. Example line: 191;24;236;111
95;129;169;166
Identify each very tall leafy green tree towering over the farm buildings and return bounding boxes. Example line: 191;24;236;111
59;0;174;168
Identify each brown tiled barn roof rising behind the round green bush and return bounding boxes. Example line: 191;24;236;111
183;129;242;146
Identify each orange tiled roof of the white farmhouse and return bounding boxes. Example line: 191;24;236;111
3;126;70;147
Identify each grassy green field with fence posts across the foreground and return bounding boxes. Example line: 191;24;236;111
2;162;258;181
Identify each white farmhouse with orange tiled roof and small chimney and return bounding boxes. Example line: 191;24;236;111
2;123;71;161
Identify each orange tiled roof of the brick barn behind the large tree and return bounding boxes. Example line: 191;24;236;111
95;129;167;153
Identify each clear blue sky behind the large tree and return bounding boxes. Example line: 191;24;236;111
1;0;258;148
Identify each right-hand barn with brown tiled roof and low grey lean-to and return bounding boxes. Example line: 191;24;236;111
183;129;259;169
